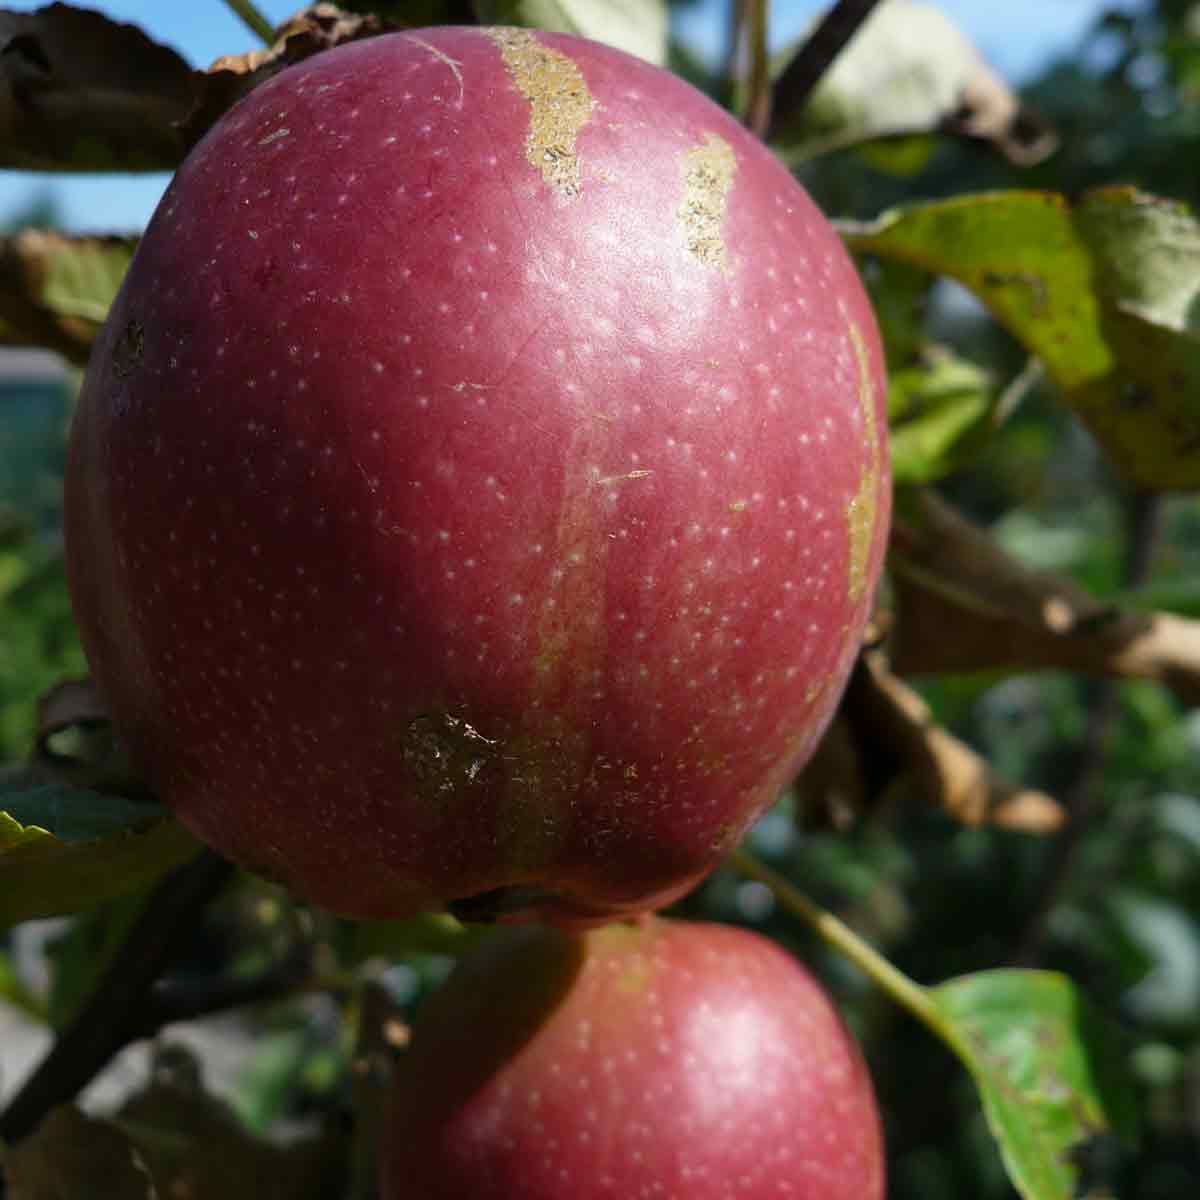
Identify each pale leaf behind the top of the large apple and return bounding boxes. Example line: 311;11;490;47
475;0;667;66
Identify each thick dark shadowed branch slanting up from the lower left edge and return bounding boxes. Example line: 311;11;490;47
0;851;233;1142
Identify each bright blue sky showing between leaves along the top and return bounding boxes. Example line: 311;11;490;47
0;0;1135;232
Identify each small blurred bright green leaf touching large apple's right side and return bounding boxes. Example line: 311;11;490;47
888;355;997;484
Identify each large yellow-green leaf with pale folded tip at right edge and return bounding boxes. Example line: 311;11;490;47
844;188;1200;488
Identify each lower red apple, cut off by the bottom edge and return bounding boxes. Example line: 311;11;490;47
380;917;884;1200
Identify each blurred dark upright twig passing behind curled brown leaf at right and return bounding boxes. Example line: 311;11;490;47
1014;492;1163;967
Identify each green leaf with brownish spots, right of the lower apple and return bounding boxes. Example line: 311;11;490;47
928;971;1136;1200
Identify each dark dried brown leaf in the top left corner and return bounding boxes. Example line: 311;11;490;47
0;4;193;170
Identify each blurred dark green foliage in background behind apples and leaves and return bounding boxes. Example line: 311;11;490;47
0;0;1200;1200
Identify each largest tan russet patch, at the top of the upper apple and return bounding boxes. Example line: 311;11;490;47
487;29;595;197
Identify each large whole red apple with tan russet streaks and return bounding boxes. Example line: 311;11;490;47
66;28;889;924
